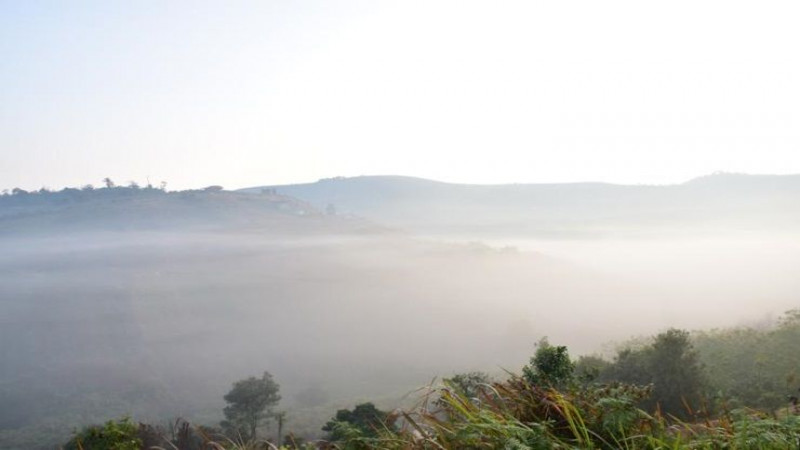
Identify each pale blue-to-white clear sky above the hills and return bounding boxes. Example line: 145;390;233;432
0;0;800;189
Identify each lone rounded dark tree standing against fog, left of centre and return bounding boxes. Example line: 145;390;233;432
222;372;281;440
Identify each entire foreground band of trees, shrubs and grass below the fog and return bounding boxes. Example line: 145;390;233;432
59;311;800;450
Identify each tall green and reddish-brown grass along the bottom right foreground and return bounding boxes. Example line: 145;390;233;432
333;377;800;450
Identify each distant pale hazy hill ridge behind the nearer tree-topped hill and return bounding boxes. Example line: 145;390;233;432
242;174;800;236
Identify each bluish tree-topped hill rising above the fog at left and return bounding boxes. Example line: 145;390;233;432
0;186;377;235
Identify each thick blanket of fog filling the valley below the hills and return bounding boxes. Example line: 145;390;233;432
0;217;800;442
